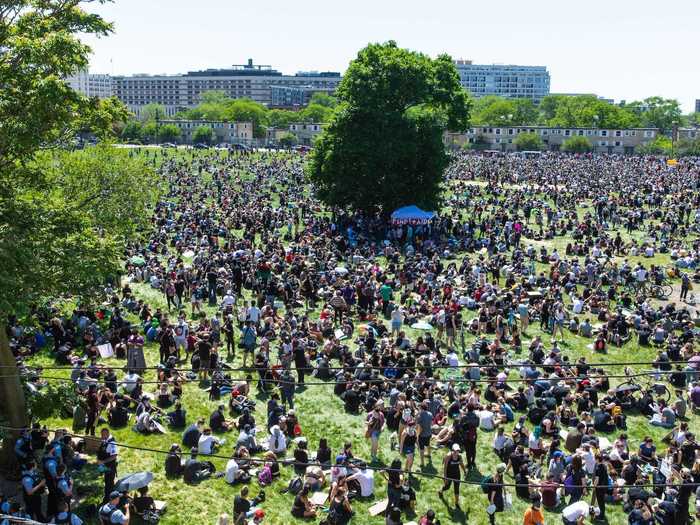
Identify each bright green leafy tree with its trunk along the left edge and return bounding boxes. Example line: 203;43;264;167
0;0;156;466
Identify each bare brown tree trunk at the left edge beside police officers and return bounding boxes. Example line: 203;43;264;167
0;323;29;474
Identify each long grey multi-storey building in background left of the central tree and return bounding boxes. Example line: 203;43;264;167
113;59;341;114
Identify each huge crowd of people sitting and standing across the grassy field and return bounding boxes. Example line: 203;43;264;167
2;148;700;525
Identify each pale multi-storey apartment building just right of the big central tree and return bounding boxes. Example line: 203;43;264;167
455;60;549;104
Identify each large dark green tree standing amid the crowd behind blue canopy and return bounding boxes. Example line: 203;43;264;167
308;41;471;215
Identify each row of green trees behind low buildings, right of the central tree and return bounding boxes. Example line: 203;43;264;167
471;95;700;133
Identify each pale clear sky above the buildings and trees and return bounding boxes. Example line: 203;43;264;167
84;0;700;112
